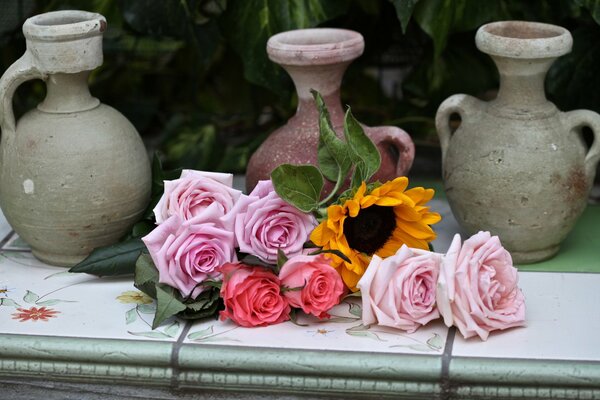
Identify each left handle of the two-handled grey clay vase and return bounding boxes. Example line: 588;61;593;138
435;94;481;166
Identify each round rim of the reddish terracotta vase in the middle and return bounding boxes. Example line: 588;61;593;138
267;28;365;65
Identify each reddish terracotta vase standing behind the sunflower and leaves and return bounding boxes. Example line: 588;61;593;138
246;28;415;191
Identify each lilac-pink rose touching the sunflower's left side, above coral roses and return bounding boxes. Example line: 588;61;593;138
230;180;317;263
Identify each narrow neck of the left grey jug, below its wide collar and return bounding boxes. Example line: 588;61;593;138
37;71;100;114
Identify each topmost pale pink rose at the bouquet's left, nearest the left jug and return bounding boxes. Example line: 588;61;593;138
154;169;242;230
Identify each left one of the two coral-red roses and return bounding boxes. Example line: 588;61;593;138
220;264;291;327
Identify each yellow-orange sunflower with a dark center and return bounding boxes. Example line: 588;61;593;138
310;177;441;291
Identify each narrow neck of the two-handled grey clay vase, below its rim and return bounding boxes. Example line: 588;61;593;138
492;56;555;109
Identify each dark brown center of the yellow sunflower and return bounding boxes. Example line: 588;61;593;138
344;206;396;254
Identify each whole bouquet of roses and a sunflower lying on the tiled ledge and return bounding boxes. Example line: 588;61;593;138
71;92;525;340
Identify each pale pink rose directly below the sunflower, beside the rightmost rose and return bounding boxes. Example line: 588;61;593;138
357;245;441;333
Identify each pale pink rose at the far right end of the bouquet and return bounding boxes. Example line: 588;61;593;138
437;232;525;340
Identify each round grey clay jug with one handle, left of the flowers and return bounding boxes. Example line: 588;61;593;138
0;11;151;266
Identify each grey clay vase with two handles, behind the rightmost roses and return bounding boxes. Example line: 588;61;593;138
436;21;600;263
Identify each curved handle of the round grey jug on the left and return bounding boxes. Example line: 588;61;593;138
0;51;45;136
